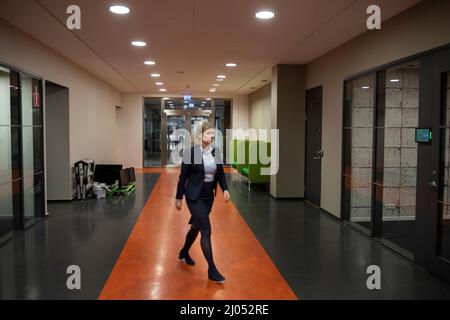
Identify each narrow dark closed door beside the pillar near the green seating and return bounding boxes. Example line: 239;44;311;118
305;87;323;207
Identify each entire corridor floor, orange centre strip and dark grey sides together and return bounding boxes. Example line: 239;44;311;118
0;169;450;299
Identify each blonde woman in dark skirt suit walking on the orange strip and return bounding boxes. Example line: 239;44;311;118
175;122;230;282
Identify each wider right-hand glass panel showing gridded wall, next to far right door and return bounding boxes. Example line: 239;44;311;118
379;61;420;253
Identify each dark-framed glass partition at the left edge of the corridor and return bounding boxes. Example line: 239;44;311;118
0;66;45;241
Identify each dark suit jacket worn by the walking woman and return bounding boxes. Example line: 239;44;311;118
177;145;228;201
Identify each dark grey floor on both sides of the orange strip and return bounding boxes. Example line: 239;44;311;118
0;174;450;299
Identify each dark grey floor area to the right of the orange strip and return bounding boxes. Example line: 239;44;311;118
228;175;450;299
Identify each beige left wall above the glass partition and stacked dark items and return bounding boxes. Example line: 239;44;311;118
0;20;122;200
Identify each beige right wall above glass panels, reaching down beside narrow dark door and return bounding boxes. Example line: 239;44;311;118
306;0;450;216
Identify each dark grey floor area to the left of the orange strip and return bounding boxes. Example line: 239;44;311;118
0;173;159;299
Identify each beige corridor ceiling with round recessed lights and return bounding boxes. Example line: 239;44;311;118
0;0;419;96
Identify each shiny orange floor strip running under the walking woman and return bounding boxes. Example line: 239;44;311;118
100;169;296;300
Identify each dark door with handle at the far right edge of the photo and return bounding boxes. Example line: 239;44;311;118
416;49;450;282
